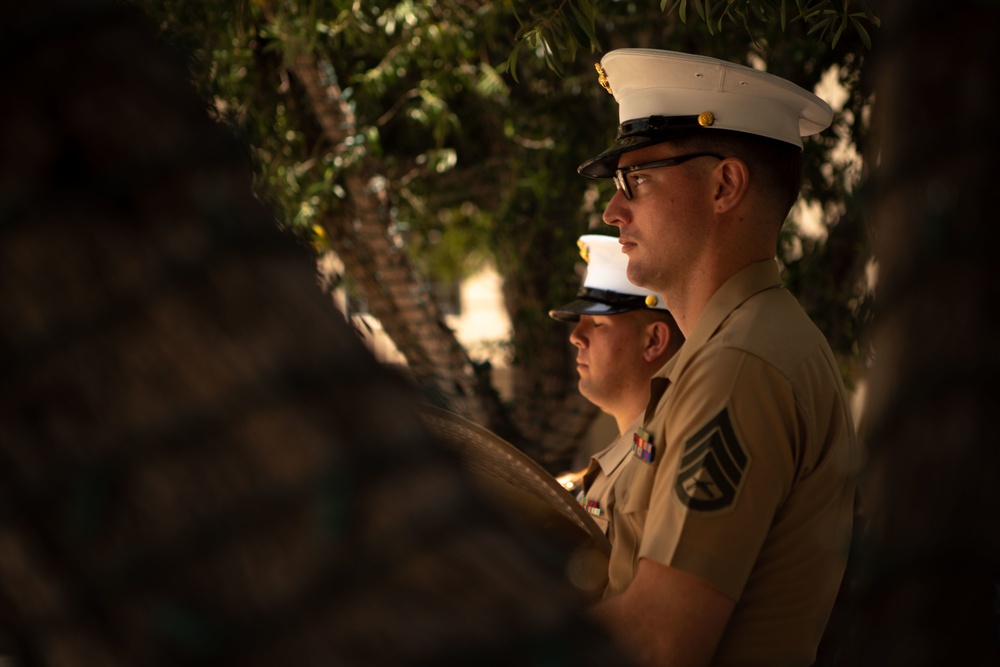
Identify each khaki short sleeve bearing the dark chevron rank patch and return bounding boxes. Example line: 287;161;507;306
639;349;801;601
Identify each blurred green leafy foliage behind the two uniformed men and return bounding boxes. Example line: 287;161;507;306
134;0;878;388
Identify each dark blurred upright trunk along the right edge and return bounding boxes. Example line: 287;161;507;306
842;0;1000;667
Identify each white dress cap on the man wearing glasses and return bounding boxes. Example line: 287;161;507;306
579;49;833;178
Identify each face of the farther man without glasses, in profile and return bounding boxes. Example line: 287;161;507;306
569;311;650;413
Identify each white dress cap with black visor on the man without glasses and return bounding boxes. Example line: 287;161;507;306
549;234;667;322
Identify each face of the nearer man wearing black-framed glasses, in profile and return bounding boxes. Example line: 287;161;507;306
604;142;719;296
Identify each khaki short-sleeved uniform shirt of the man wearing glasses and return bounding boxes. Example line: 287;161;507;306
584;260;859;665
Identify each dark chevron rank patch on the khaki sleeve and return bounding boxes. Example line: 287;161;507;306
674;408;750;512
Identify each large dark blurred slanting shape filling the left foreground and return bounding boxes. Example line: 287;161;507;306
0;0;621;666
